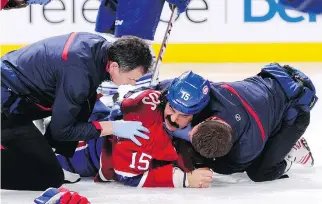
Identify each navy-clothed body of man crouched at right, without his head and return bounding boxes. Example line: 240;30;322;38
157;64;318;181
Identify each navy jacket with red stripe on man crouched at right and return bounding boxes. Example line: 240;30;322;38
157;76;291;164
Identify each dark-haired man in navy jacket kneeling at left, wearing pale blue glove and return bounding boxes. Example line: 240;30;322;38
0;32;152;190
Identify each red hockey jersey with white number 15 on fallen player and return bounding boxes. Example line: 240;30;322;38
96;90;178;187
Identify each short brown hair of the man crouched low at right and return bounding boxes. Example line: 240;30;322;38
191;120;233;158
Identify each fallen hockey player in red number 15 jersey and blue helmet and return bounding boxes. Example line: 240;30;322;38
96;72;213;187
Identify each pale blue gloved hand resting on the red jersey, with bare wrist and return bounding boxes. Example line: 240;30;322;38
99;120;150;146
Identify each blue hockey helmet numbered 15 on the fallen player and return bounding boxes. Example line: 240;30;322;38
166;71;210;115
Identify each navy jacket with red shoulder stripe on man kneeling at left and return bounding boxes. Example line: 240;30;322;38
1;33;110;141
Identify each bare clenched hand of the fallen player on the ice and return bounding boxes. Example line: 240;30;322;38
187;168;213;188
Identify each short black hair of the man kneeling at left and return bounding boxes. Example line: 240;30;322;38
107;36;152;73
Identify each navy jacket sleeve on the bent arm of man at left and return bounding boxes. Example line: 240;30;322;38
50;67;100;141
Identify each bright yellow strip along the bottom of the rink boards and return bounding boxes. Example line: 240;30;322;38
0;43;322;62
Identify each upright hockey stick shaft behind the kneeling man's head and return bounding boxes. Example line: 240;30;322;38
150;5;178;86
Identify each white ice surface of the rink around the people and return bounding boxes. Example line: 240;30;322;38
1;63;322;204
